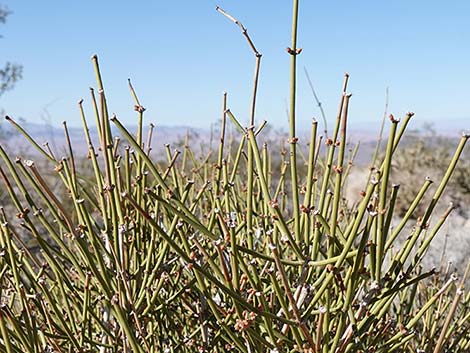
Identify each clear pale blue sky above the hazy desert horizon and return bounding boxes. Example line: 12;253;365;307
0;0;470;133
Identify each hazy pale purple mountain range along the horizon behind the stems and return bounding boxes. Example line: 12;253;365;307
0;118;462;164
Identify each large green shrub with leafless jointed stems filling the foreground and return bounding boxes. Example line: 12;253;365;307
0;2;470;353
